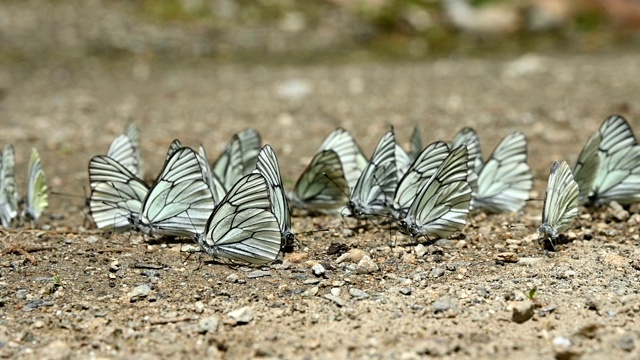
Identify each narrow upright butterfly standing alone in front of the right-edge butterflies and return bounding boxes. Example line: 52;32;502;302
538;161;579;249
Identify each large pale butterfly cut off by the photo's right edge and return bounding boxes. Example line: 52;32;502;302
588;115;640;206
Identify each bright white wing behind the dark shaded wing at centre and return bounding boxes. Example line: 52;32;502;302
318;128;369;190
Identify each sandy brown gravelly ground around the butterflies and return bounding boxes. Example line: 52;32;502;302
0;53;640;359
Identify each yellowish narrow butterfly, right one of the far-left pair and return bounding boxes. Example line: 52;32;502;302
23;148;49;222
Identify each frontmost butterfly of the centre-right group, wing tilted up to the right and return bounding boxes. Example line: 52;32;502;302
398;146;471;238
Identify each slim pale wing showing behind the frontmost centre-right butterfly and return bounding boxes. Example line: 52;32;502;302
392;141;450;219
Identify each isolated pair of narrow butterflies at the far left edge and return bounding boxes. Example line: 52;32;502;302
0;144;49;228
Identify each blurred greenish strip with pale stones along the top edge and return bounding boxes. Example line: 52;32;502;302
0;0;640;64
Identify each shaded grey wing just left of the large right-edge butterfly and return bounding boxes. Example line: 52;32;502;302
573;131;602;204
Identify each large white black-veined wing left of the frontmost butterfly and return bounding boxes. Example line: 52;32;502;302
136;147;215;236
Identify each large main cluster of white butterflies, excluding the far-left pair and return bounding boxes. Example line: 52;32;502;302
89;116;640;264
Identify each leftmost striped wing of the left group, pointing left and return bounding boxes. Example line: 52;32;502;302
89;155;149;231
